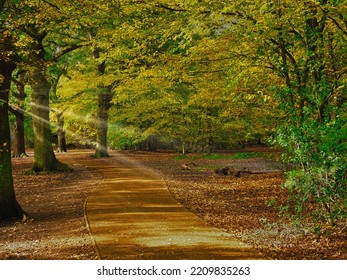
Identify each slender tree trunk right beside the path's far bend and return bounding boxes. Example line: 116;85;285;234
95;87;112;157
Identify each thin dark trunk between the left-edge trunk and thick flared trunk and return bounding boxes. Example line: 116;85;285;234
12;71;26;157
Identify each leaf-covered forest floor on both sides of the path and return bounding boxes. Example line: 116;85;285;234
0;150;347;260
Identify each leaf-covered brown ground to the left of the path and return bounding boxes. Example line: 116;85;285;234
0;154;103;259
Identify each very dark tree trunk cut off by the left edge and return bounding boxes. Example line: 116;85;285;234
0;60;24;220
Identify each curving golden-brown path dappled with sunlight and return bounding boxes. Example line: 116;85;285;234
64;153;266;260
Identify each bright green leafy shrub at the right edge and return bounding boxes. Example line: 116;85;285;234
277;119;347;224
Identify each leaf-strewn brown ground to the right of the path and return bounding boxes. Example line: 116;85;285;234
123;152;347;260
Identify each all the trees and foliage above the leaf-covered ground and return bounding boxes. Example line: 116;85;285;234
0;0;347;235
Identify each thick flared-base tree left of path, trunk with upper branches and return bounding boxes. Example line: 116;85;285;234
24;4;88;171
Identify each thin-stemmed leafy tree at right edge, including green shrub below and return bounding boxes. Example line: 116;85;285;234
219;0;347;224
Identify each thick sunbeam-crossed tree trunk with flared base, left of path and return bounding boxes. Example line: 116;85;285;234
30;64;69;172
